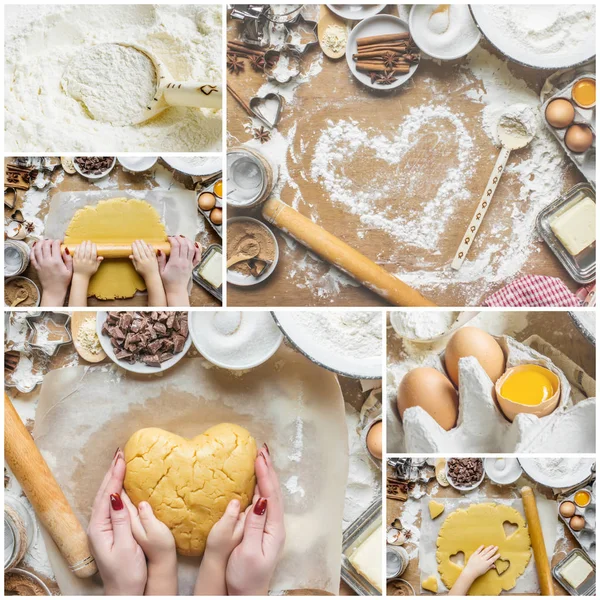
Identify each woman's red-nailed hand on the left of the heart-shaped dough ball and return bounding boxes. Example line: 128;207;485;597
88;449;147;596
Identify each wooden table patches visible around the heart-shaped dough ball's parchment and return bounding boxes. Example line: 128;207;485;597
5;314;367;596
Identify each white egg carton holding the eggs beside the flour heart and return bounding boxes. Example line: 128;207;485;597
542;73;596;185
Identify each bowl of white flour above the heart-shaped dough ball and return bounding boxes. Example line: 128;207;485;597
273;310;384;379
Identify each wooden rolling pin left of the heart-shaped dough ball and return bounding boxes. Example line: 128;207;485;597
4;394;98;578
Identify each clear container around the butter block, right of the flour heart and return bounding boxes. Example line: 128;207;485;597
536;183;596;284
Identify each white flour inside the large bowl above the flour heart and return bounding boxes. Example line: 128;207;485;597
486;4;596;55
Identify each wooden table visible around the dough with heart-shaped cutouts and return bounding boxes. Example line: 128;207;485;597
386;465;579;596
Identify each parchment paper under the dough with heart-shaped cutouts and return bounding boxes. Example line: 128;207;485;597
419;494;558;595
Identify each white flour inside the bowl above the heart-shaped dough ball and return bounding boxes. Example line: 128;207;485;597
294;311;383;358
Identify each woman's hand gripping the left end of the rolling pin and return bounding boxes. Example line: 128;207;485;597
31;240;73;306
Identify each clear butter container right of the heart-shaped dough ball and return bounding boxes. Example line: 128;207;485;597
342;500;385;596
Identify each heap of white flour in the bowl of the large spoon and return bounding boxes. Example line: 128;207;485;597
61;44;156;125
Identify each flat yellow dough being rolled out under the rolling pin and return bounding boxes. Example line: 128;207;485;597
65;198;167;300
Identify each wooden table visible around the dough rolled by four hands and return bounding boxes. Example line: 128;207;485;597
4;158;222;307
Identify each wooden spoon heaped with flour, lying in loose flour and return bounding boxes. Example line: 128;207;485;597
61;43;222;126
